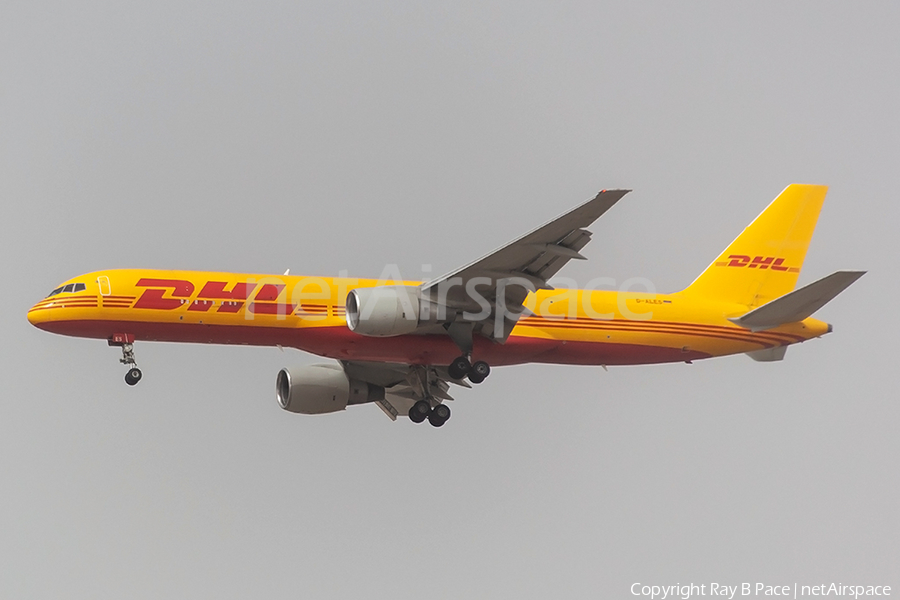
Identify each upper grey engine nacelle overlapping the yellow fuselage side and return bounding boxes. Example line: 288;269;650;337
347;285;419;337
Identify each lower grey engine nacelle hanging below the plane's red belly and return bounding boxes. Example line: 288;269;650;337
275;364;384;415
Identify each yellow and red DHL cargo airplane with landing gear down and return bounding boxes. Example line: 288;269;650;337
28;184;865;427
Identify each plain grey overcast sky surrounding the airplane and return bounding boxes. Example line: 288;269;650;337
0;1;900;599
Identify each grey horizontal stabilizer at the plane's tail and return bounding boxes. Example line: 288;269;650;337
728;271;866;331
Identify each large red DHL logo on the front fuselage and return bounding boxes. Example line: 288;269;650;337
134;278;296;315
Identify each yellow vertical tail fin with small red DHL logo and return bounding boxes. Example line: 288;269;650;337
684;183;828;307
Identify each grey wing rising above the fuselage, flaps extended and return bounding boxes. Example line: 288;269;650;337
421;190;631;345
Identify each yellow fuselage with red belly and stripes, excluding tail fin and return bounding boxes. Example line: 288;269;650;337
28;269;830;365
